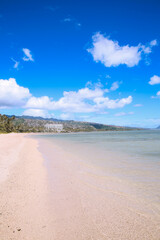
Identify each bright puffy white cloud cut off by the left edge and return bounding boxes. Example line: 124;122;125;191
0;78;31;108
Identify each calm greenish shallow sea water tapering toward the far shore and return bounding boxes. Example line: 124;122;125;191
34;130;160;217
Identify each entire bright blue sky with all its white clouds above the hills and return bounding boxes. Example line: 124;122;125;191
0;0;160;127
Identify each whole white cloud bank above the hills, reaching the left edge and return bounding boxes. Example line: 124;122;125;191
0;78;132;117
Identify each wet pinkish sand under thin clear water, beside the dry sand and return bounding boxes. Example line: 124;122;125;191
39;136;160;240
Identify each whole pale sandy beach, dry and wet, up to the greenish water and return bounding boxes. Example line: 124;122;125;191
0;134;160;240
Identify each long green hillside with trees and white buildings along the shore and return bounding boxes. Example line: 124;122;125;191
0;114;141;133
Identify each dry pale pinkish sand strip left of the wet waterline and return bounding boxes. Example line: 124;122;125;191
0;134;54;240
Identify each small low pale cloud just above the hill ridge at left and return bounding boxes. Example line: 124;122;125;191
22;109;54;118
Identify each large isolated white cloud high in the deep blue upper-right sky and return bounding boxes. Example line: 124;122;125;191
87;33;157;67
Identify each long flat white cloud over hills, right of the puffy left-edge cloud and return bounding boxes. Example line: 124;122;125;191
25;87;132;113
